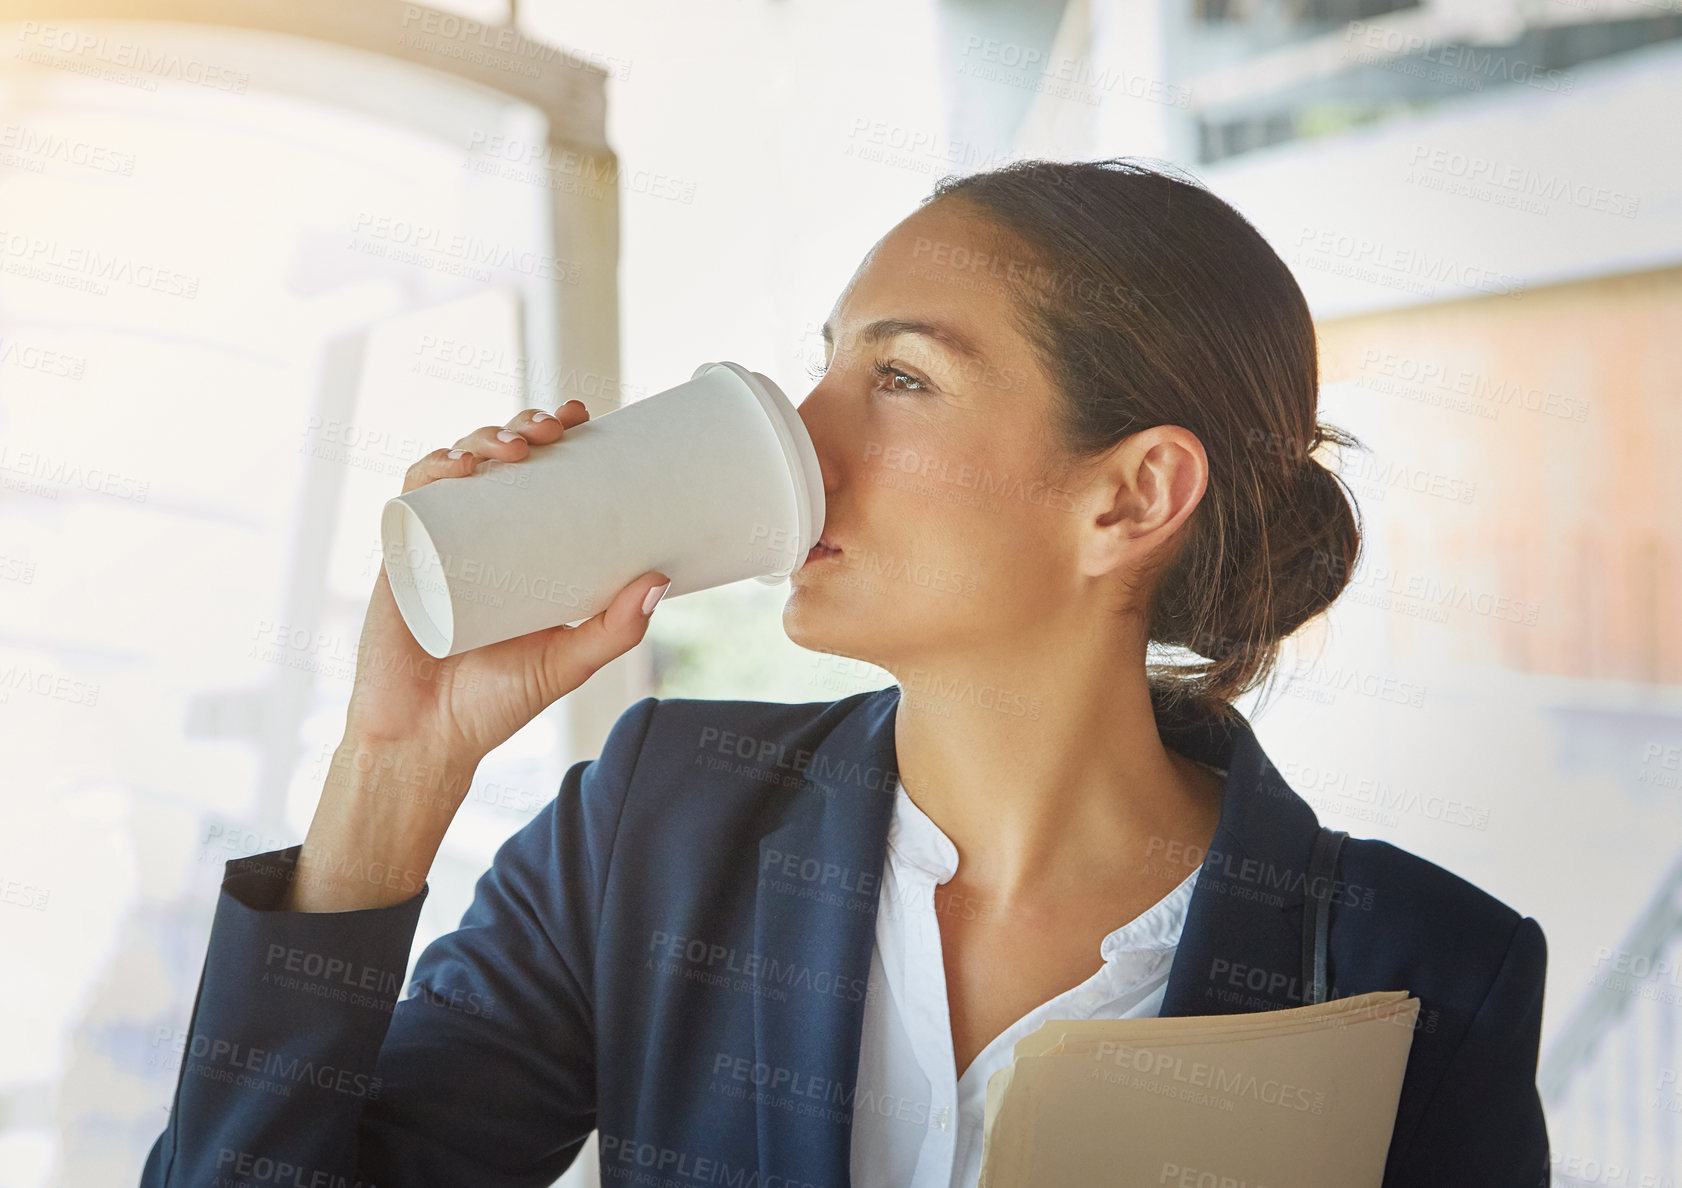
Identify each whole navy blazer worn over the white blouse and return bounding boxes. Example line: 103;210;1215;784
140;685;1547;1188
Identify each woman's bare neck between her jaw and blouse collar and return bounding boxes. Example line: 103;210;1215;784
895;648;1221;902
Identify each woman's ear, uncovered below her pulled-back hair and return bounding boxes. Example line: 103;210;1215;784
1080;424;1209;577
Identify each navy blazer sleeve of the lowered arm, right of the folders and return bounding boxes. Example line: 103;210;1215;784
1384;917;1549;1188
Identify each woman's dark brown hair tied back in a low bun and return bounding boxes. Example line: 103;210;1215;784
923;158;1361;719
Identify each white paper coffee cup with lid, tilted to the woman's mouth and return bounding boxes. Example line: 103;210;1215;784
380;363;824;660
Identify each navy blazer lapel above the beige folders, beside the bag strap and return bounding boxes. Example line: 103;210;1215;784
1154;698;1319;1016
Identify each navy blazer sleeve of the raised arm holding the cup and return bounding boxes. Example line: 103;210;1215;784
140;697;658;1188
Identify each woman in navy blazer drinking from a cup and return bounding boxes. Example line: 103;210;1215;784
141;162;1547;1188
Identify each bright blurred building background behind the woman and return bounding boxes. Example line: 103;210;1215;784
0;0;1682;1188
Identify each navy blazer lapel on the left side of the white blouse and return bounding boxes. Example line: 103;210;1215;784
754;685;900;1185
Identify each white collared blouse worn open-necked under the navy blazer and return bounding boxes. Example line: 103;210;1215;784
849;764;1224;1188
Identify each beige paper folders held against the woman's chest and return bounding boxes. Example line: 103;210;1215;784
981;989;1420;1188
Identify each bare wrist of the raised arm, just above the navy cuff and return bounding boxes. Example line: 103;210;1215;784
281;735;478;912
